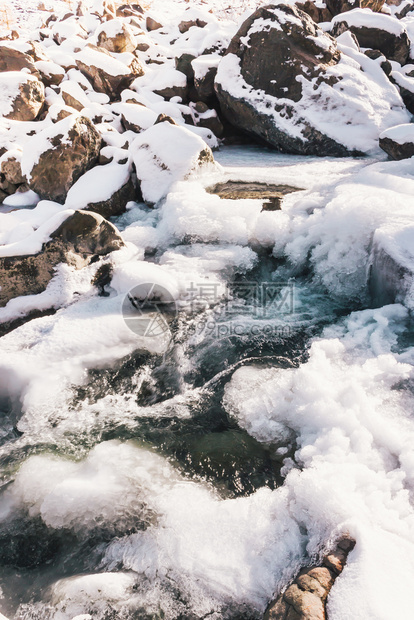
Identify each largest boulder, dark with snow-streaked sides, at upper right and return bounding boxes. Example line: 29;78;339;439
215;4;408;156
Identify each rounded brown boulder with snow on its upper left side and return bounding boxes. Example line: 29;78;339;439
22;114;102;204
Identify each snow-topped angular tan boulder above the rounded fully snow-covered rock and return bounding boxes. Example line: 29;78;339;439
76;45;144;99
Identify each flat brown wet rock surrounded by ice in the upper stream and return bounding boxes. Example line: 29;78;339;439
206;181;301;211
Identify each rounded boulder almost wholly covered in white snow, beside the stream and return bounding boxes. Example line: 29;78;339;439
131;122;214;205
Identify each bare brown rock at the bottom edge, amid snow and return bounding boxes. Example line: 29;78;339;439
264;537;355;620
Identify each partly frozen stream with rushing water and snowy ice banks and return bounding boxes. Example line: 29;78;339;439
0;147;414;620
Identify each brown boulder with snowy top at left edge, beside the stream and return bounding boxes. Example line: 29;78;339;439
0;211;124;307
